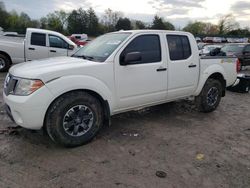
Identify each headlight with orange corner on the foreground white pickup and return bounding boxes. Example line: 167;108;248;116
13;78;44;96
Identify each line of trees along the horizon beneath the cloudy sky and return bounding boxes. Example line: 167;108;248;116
0;1;250;36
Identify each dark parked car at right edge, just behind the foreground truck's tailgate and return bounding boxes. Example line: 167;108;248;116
221;43;250;67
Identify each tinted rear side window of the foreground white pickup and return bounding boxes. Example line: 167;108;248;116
167;35;191;61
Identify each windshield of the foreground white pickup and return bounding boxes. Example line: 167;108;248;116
72;32;131;62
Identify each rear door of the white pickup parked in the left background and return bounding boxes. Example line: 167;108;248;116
25;33;49;61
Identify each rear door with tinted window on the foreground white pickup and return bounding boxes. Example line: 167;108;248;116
165;34;199;99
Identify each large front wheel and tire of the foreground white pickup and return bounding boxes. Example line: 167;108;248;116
45;91;103;147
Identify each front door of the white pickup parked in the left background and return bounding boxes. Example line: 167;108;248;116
49;35;69;57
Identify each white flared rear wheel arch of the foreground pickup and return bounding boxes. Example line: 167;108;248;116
194;64;226;96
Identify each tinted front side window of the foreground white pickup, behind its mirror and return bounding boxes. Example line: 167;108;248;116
120;35;161;64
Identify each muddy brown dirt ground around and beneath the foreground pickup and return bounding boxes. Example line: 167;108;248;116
0;68;250;188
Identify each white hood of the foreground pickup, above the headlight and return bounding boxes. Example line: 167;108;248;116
9;57;104;82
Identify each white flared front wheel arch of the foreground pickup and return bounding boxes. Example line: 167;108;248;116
45;75;115;113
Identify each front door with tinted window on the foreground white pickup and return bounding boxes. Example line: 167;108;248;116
115;34;167;110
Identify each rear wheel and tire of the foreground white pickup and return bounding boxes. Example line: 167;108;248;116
195;79;222;112
